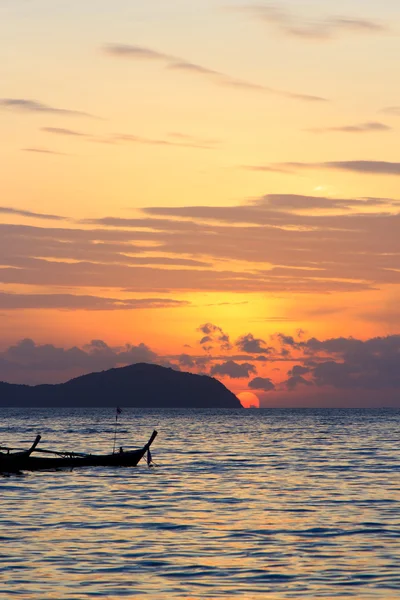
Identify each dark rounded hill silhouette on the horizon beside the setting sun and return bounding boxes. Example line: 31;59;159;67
0;363;242;408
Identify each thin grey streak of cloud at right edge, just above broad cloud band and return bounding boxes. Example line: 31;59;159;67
245;160;400;176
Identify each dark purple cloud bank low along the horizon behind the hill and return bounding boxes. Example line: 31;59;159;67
0;331;400;406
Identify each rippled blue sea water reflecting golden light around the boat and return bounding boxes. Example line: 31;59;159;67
0;409;400;600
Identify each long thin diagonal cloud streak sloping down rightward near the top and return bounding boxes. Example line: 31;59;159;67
103;44;326;102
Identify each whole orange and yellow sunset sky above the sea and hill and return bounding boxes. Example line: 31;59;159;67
0;0;400;407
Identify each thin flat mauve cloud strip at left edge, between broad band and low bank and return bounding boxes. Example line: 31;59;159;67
0;292;189;310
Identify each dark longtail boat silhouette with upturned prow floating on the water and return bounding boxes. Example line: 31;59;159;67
0;430;157;473
